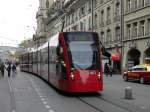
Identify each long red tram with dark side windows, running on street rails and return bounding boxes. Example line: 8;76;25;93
21;32;103;92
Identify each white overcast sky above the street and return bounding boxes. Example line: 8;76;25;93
0;0;39;46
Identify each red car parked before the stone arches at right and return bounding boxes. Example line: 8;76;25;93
123;65;150;84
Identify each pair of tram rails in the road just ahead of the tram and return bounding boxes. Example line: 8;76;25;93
77;93;149;112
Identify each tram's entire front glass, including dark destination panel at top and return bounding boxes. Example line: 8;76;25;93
65;32;100;70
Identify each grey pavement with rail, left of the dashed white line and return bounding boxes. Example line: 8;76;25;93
0;72;47;112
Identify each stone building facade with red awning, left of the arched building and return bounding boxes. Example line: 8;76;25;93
93;0;122;73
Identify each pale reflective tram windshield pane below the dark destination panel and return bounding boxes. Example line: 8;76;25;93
68;41;99;70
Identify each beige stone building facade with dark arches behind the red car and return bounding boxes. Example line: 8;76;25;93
122;0;150;68
